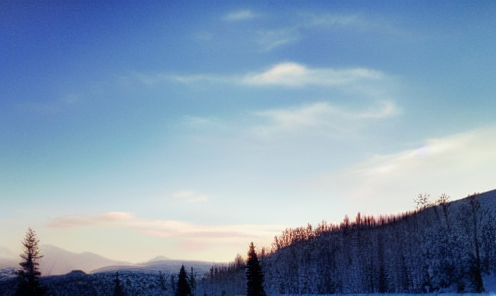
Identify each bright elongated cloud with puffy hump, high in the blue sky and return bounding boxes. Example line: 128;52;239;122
242;62;384;87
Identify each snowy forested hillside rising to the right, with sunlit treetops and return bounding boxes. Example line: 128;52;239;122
202;191;496;295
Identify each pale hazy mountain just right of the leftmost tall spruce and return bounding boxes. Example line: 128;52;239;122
40;245;132;276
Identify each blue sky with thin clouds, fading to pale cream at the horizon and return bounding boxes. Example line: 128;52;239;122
0;0;496;262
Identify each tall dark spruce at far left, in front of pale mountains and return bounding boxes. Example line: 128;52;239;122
17;228;45;296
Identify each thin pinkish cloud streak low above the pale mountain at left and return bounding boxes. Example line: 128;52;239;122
48;212;134;228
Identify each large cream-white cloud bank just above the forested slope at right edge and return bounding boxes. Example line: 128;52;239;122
328;127;496;213
